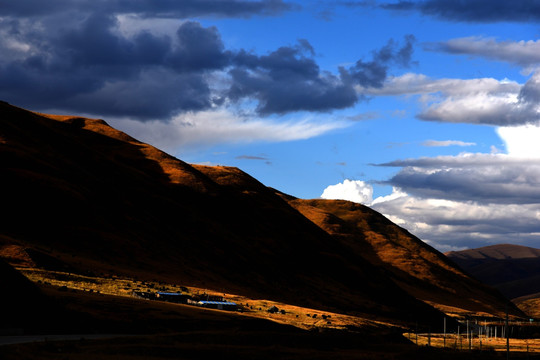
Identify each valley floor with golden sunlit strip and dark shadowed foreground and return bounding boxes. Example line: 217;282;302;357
4;269;540;360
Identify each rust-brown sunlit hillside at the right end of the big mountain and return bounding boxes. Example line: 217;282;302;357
288;197;520;316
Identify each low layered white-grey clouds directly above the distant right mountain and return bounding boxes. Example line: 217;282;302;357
372;196;540;251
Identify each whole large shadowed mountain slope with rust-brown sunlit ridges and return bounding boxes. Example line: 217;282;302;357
0;103;523;326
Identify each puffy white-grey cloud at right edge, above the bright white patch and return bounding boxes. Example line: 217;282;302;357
358;72;540;126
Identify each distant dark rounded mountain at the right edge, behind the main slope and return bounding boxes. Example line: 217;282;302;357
446;244;540;299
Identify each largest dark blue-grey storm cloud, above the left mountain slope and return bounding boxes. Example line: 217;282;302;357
0;13;229;119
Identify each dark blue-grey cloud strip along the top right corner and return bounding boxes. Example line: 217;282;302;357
380;0;540;23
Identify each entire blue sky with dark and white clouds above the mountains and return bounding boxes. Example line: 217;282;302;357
0;0;540;251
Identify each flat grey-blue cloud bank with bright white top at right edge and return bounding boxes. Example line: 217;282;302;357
379;125;540;205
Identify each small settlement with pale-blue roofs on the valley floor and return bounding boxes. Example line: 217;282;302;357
133;291;238;311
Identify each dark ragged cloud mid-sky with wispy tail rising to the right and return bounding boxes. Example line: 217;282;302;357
227;35;414;114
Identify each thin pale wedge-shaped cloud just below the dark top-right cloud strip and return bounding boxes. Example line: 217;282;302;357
424;36;540;67
